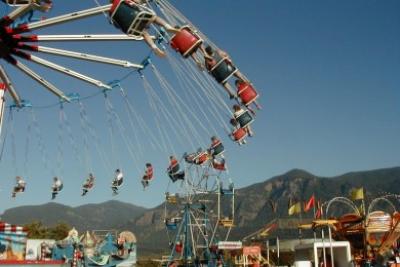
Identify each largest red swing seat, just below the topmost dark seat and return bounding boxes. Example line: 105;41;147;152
170;26;203;58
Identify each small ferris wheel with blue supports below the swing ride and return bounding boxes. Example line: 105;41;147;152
164;150;235;266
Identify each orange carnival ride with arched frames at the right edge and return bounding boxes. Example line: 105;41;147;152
302;194;400;263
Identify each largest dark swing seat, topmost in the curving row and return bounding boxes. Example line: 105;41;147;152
110;0;155;37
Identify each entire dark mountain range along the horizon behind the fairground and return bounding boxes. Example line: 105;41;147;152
1;167;400;255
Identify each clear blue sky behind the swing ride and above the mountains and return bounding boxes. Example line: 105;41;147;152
0;0;400;214
